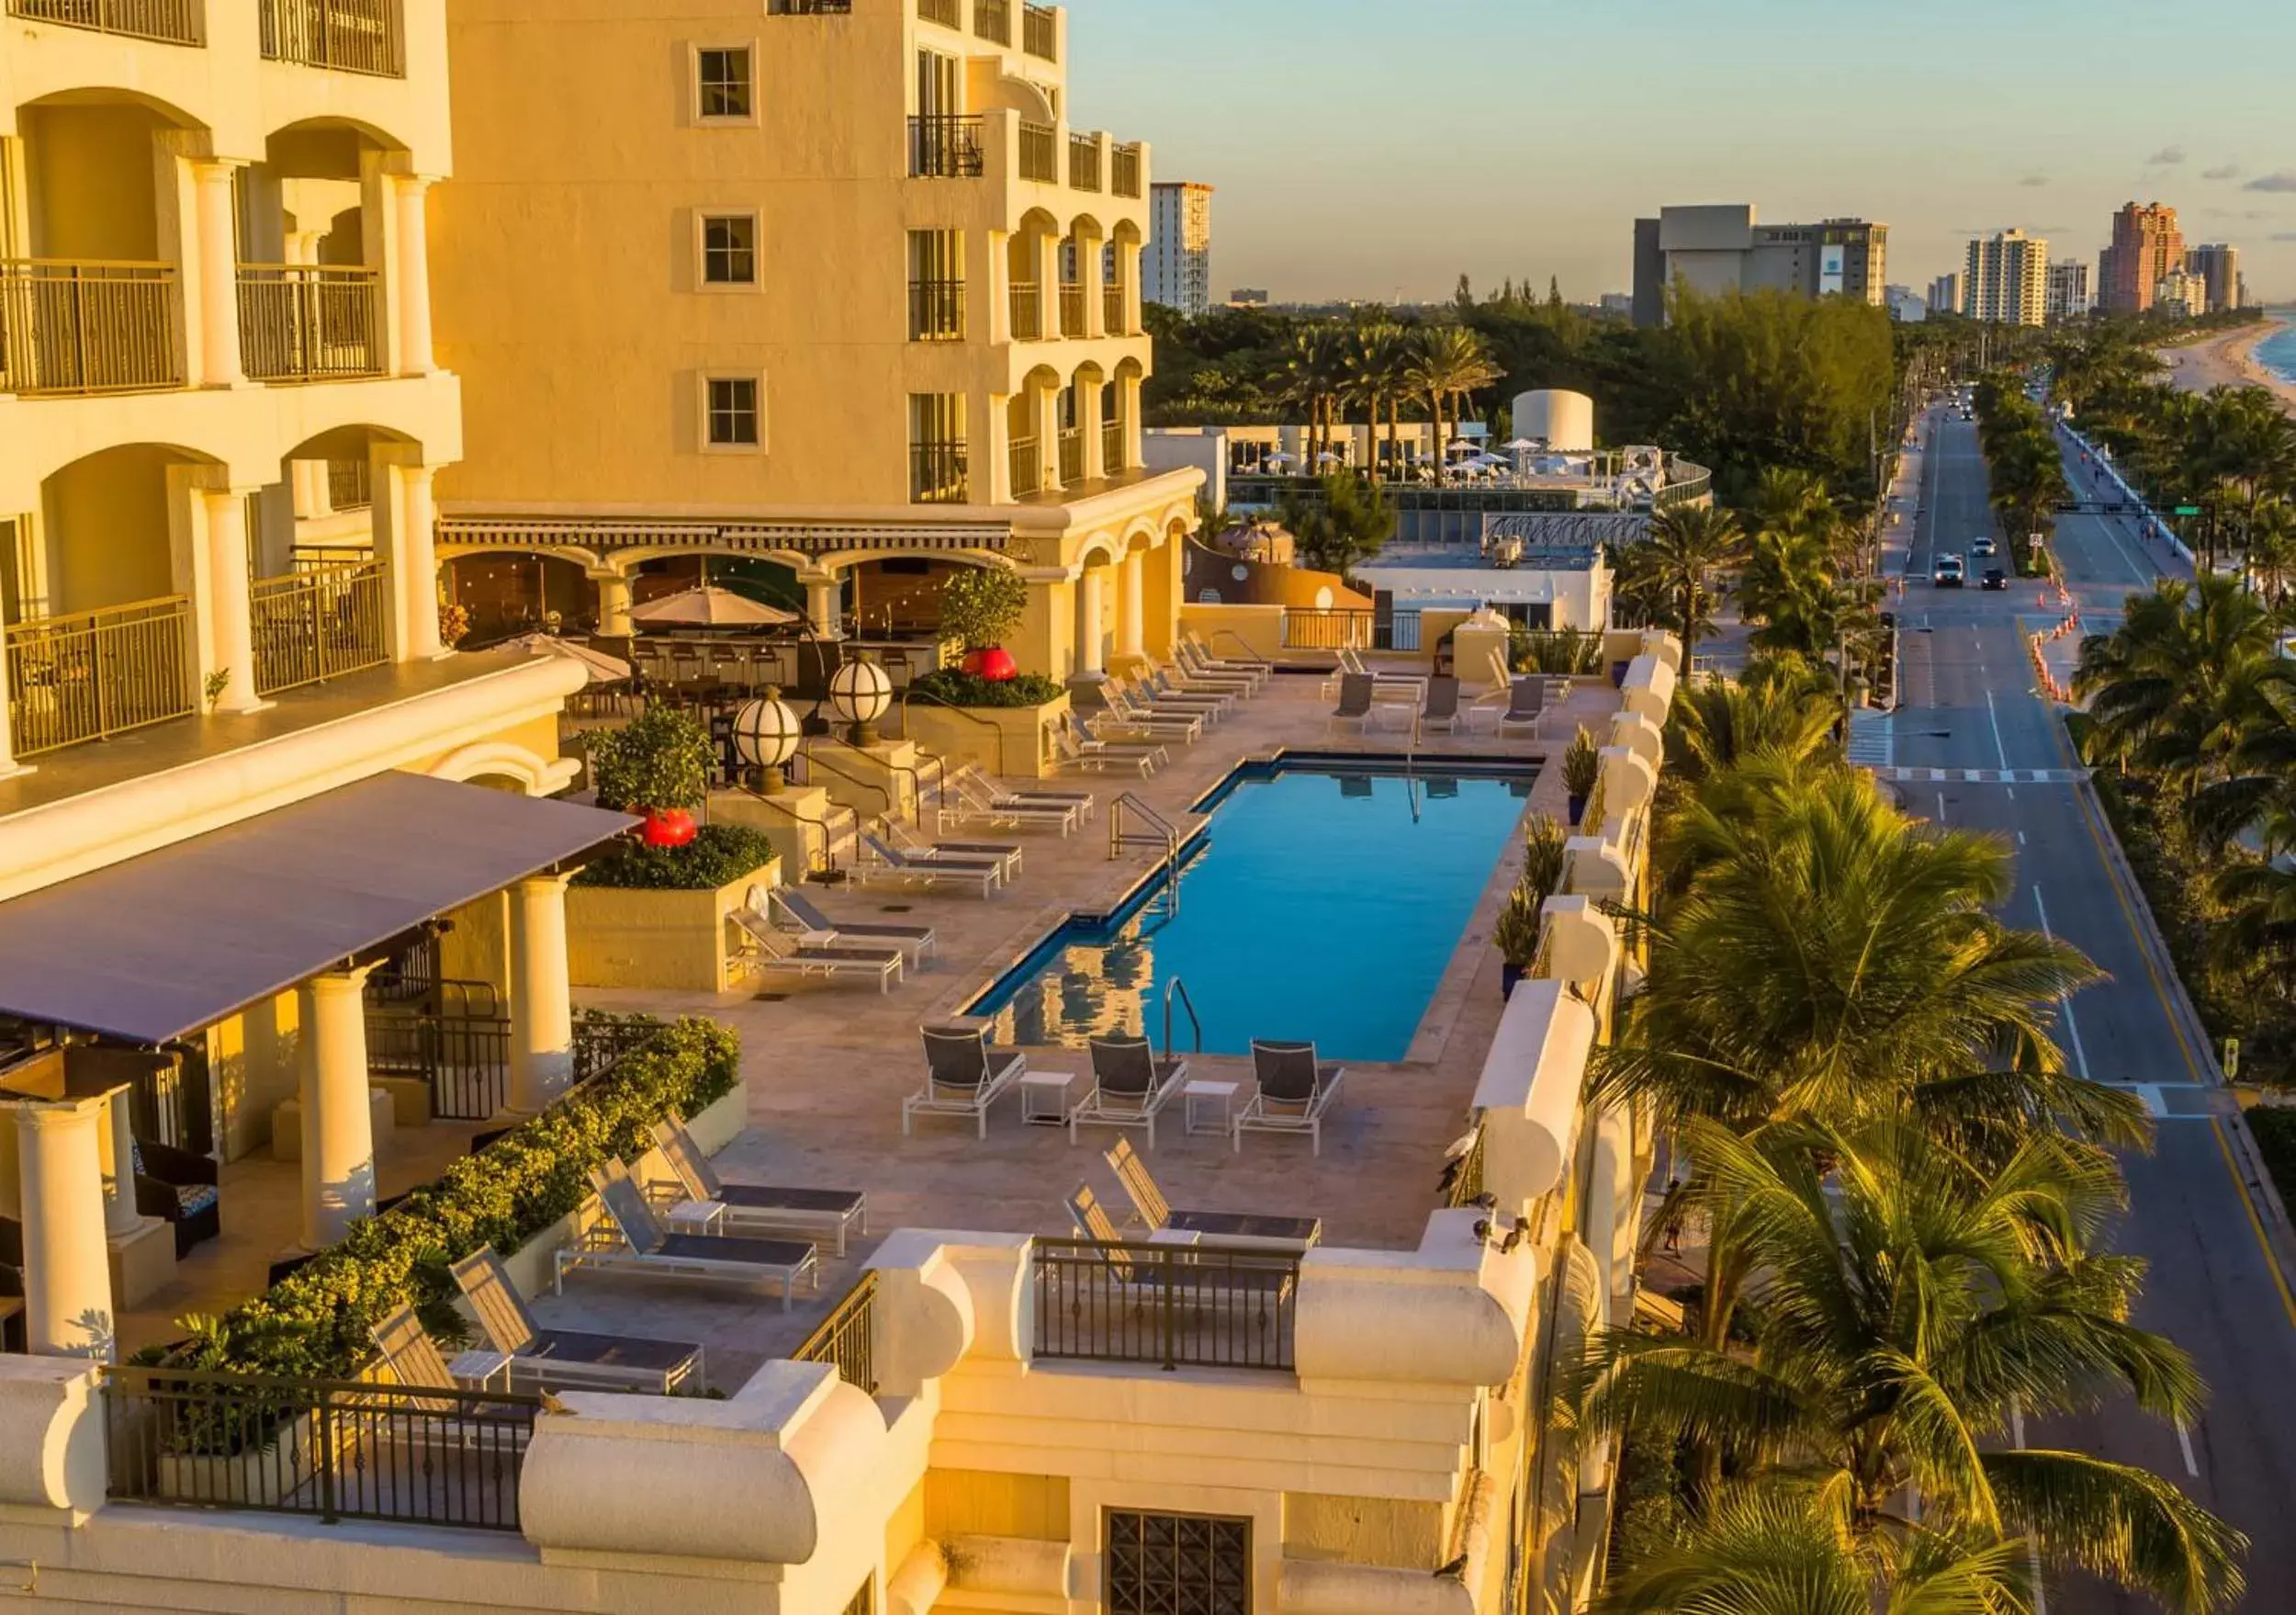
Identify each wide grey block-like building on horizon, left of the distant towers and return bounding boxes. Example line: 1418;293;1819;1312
1635;202;1890;326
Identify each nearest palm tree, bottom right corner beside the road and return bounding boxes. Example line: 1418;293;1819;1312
1569;1121;2248;1615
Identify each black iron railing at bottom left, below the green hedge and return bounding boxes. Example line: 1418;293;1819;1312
104;1364;542;1530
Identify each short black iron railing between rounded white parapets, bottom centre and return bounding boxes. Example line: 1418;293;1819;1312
1029;1238;1300;1369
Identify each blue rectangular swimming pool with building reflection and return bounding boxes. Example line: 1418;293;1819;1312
967;761;1534;1061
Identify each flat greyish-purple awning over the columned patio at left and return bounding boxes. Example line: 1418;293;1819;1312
0;774;636;1043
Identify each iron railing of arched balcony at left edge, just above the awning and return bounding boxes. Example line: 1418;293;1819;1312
7;595;193;756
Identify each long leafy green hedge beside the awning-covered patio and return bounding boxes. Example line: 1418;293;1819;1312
165;1018;742;1378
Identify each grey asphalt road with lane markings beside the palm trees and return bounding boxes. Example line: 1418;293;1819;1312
1863;412;2296;1615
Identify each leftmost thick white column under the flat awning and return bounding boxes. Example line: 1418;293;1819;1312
17;1098;115;1360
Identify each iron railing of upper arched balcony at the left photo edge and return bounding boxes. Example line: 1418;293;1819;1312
0;257;184;393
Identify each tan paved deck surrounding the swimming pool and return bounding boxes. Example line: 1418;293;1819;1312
535;675;1619;1385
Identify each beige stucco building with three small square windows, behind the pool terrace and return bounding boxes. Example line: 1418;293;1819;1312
432;0;1199;680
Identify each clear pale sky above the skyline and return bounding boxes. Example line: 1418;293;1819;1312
1068;0;2296;301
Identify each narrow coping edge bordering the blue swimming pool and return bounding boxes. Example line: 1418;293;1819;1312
928;747;1548;1070
